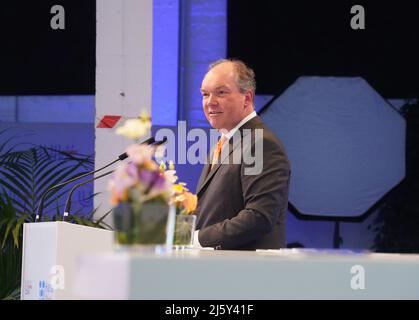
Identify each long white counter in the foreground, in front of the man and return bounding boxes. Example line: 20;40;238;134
74;249;419;300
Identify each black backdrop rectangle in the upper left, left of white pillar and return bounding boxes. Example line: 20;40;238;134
0;0;96;95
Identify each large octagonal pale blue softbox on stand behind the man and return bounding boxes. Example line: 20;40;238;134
261;77;406;218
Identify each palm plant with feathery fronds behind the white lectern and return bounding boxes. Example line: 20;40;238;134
0;131;110;299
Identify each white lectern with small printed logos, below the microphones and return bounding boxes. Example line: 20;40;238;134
20;222;114;300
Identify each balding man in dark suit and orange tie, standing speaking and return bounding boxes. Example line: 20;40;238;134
194;59;290;250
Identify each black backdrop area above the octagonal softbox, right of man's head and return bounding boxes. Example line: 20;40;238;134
228;0;419;98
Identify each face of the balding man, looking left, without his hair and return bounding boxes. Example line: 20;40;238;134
201;62;253;130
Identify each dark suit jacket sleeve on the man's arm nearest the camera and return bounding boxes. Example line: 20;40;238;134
198;134;290;249
